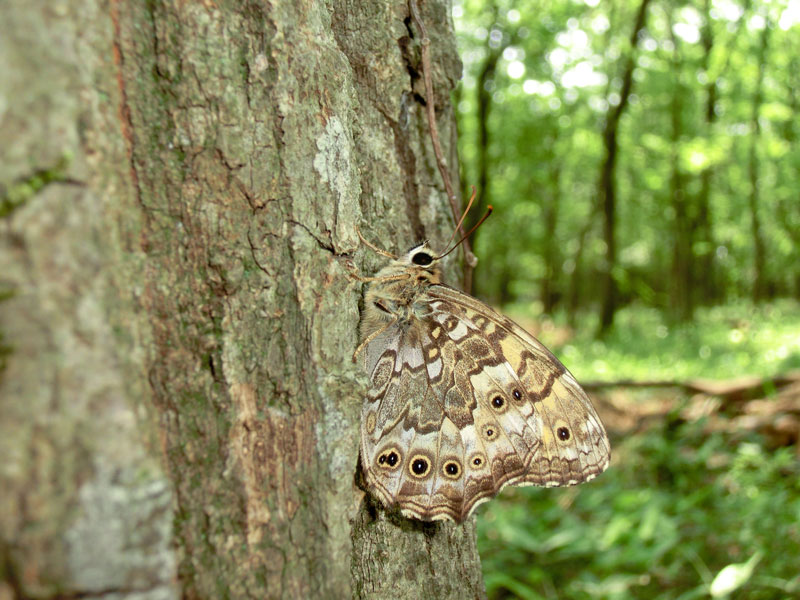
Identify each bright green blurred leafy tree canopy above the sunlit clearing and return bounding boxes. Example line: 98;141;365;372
454;0;800;319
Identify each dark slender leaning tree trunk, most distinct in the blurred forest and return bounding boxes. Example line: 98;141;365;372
597;0;650;334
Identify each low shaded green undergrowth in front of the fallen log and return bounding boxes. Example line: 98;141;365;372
478;423;800;599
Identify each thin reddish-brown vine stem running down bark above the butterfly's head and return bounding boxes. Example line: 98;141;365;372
408;0;478;292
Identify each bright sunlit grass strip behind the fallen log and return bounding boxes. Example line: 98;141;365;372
539;301;800;381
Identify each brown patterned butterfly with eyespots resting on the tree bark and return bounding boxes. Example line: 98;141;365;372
353;214;610;523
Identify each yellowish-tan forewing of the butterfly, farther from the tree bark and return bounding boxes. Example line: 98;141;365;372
429;285;610;486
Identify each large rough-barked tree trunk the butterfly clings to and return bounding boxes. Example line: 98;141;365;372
0;0;483;599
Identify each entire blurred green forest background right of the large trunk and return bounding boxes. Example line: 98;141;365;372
454;0;800;598
